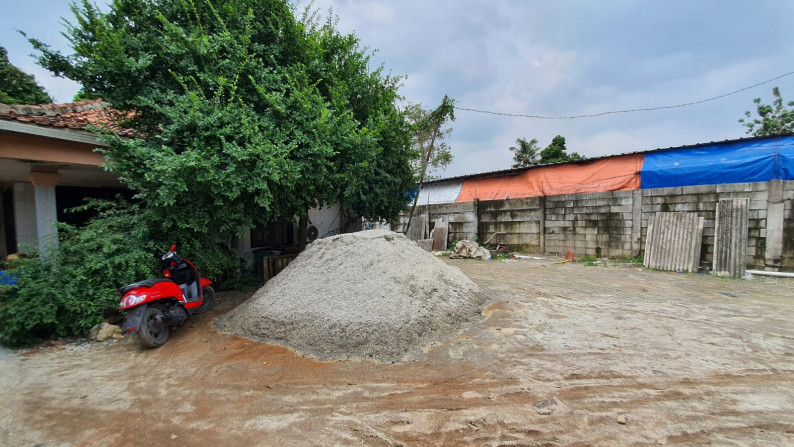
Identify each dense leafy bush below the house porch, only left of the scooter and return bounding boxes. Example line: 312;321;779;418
0;202;157;346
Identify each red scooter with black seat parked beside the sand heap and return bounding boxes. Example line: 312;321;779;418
119;244;215;348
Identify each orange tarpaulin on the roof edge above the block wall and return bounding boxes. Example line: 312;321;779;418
456;154;643;203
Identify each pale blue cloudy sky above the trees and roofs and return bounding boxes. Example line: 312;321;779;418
0;0;794;177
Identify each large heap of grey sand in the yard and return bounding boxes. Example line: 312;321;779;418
216;230;486;361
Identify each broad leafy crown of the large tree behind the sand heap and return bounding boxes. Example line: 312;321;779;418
31;0;414;270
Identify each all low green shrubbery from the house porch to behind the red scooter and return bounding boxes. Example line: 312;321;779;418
0;199;254;346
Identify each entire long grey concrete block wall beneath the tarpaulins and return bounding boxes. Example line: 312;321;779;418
396;180;794;270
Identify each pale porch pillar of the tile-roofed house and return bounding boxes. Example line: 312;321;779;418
28;171;61;257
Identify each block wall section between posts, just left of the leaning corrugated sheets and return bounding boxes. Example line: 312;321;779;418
545;191;634;257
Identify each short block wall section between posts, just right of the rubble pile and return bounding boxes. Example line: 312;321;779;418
477;197;545;253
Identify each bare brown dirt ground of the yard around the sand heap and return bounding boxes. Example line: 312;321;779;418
0;260;794;447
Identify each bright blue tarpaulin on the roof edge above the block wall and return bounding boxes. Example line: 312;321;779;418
640;136;794;189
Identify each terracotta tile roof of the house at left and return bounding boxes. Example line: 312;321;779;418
0;100;136;137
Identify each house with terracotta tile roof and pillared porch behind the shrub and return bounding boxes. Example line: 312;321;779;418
0;100;132;259
